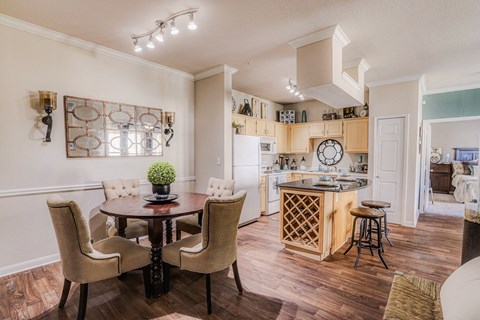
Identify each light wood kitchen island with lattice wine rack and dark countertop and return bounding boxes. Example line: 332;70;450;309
278;178;370;260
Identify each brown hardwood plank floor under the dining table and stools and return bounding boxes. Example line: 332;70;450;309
0;214;463;319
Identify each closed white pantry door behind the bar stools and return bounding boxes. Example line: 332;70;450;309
373;117;406;223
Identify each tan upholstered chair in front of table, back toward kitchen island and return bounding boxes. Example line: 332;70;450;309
162;190;247;314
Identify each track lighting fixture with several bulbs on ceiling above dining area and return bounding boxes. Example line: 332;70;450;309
132;8;198;52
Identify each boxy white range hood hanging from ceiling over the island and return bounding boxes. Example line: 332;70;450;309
289;25;370;108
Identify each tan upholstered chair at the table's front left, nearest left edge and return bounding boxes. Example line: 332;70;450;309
47;196;151;319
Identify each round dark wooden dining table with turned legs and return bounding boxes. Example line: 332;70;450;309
100;192;208;298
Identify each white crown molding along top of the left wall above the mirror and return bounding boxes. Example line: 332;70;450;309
0;14;194;80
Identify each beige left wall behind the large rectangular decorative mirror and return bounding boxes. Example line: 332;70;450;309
0;26;194;273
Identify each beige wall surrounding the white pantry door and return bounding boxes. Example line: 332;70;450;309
368;81;421;226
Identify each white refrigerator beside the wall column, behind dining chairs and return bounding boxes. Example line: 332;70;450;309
233;134;260;225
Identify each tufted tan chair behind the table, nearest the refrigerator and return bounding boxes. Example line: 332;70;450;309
175;178;235;240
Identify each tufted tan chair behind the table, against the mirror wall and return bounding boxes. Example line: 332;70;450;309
89;179;148;243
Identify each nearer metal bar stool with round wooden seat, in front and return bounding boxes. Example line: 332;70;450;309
343;208;388;269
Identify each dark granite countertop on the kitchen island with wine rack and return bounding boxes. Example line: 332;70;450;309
278;178;371;192
